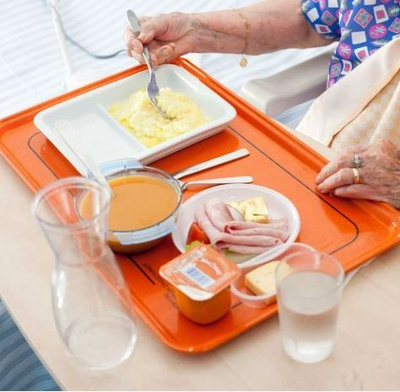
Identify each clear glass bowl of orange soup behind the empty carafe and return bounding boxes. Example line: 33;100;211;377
92;159;182;253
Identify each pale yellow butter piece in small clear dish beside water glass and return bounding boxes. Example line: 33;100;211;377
244;261;291;302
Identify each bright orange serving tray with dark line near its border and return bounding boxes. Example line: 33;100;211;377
0;59;400;353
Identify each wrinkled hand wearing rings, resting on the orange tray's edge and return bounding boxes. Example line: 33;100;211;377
316;140;400;208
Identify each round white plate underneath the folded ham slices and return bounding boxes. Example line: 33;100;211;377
172;184;300;266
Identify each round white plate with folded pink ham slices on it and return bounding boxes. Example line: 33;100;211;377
172;184;300;264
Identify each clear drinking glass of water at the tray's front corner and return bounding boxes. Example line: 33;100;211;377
276;249;344;363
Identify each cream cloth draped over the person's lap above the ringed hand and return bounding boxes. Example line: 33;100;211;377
297;38;400;152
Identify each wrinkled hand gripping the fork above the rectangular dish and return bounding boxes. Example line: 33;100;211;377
124;13;198;65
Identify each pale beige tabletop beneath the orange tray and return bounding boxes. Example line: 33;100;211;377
0;127;400;390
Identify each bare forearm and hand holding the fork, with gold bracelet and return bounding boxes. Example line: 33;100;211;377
124;0;330;65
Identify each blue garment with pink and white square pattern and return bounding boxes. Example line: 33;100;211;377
302;0;400;87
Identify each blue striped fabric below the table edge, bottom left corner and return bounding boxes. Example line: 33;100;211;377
0;300;60;391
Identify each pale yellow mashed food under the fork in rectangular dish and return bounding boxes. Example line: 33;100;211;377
108;88;206;148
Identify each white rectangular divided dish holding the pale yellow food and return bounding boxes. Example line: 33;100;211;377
34;64;236;175
